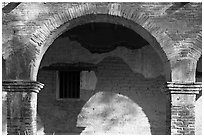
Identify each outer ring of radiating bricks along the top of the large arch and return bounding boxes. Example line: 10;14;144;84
31;3;172;70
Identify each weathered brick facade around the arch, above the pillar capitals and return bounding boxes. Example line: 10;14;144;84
2;2;202;135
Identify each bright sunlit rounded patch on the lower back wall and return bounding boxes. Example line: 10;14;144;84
77;92;151;135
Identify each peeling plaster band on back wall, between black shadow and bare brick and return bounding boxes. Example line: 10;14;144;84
40;37;164;78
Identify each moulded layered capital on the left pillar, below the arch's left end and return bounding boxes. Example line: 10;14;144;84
2;80;44;93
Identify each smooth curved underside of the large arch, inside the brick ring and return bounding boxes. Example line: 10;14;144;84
32;14;171;81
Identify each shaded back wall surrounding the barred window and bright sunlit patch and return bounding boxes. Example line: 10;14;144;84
38;39;166;134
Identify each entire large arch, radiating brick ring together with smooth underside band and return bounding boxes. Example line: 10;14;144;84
30;3;174;79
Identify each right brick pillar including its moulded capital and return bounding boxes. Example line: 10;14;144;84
167;82;202;135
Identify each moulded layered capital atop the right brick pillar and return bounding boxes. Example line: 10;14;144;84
167;82;202;94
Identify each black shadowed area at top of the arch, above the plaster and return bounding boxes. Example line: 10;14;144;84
59;23;148;53
